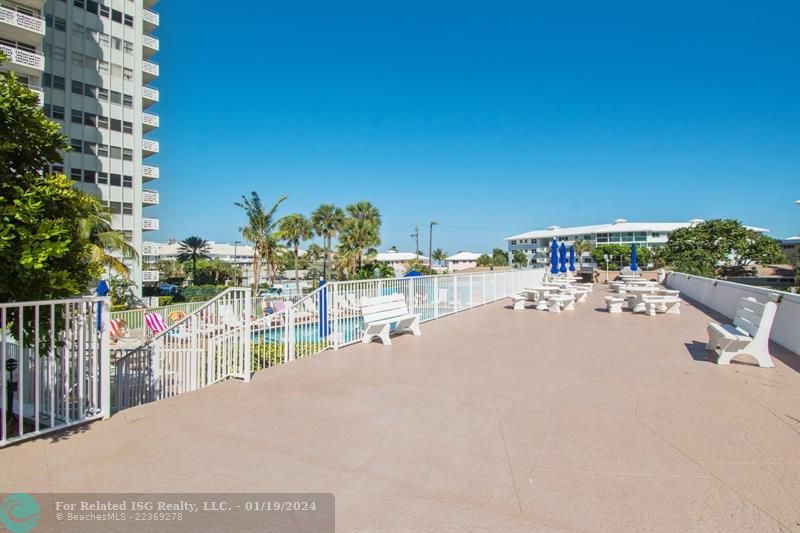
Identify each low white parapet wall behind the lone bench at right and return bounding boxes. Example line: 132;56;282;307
666;272;800;355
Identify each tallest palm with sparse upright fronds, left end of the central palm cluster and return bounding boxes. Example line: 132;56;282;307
234;191;288;294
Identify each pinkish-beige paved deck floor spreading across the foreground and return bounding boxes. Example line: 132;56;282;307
0;286;800;532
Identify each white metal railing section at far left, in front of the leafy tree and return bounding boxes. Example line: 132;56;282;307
0;298;110;446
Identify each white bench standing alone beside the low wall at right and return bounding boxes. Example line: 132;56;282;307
706;298;778;368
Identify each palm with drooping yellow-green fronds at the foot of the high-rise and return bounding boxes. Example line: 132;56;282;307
79;202;139;278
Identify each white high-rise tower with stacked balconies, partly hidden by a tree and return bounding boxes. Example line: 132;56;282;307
0;0;160;294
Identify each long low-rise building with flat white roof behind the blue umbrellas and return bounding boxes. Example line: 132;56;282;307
505;218;769;267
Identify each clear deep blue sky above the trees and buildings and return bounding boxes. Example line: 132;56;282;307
145;0;800;253
